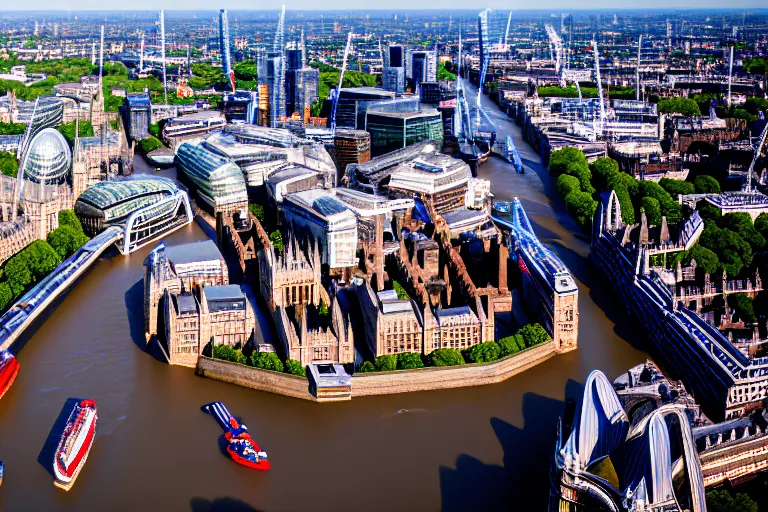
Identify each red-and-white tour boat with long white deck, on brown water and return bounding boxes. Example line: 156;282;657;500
53;400;99;491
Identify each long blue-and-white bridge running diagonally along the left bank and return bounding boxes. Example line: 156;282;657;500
0;226;124;350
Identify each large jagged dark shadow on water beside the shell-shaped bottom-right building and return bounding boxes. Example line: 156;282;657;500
440;379;584;512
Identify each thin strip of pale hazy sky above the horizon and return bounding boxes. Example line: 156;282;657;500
0;0;768;12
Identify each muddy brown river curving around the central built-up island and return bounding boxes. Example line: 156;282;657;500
0;91;646;511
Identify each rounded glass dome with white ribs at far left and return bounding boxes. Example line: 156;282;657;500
22;128;72;185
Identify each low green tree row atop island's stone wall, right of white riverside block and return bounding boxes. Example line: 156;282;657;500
359;324;552;373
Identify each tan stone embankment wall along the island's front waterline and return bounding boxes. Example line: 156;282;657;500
195;341;555;402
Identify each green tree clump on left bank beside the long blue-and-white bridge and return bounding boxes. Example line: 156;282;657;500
0;210;88;310
